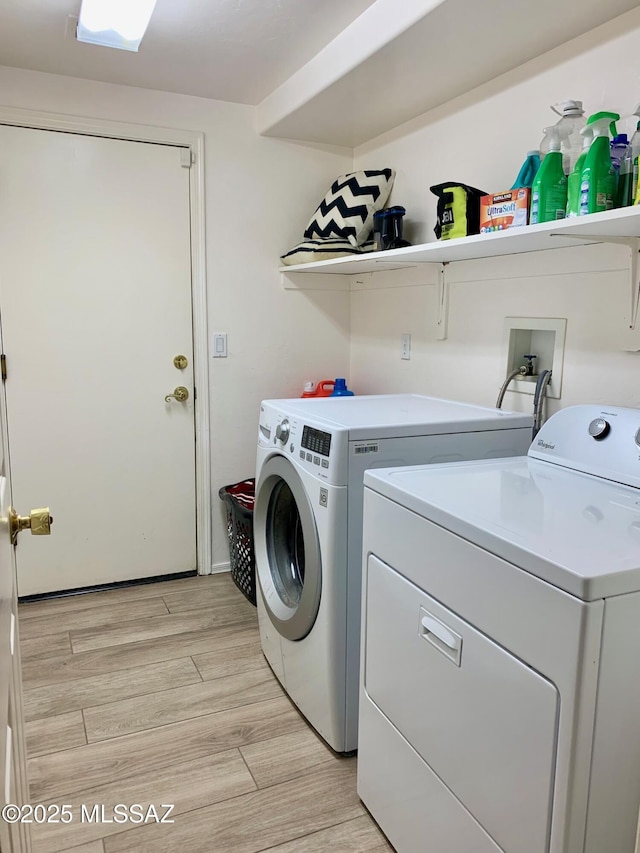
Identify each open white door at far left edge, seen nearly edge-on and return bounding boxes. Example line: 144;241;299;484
0;320;31;853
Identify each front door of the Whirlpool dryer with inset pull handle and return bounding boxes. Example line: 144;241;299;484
360;543;560;853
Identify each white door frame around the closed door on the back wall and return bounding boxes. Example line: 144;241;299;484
0;106;213;575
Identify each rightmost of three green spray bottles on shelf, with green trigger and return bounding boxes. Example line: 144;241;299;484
579;112;620;216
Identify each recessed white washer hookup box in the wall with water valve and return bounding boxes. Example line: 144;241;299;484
503;317;567;400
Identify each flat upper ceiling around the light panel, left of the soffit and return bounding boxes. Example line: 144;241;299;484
0;0;375;104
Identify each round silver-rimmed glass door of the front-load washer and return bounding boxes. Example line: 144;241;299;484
253;456;322;640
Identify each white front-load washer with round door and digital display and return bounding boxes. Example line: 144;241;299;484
253;394;532;752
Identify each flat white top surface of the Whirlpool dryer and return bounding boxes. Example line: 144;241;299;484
364;457;640;601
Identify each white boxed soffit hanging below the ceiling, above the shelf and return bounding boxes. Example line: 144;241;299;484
256;0;637;148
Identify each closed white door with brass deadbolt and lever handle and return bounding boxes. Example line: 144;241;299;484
0;126;196;595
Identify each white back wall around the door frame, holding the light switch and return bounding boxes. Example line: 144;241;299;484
0;67;352;565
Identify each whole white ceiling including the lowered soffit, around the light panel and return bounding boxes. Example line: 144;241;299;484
0;0;640;148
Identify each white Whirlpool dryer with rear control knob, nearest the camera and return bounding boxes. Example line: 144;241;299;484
358;406;640;853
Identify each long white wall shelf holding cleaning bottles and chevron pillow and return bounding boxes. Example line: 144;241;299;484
280;206;640;275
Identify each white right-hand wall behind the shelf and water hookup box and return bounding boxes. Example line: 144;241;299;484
350;9;640;411
